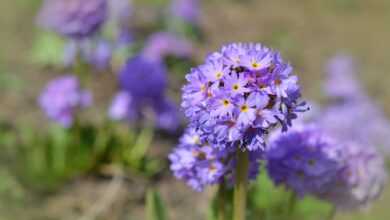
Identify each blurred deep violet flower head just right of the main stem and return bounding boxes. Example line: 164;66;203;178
266;125;345;196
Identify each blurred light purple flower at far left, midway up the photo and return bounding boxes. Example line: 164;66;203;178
39;75;92;127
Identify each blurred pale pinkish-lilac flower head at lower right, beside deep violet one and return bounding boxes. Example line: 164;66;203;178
318;142;387;210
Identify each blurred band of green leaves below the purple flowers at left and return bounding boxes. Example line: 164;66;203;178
0;123;164;191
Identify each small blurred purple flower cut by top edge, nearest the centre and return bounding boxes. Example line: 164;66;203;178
170;0;200;24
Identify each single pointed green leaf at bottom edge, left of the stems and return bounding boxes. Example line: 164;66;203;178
146;189;168;220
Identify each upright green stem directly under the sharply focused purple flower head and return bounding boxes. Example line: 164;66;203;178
233;150;249;220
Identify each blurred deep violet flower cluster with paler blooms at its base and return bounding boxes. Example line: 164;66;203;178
109;55;180;131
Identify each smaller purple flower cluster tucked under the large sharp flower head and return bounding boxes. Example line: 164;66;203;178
169;128;261;191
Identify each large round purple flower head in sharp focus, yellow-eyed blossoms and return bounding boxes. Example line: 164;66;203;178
182;43;306;151
